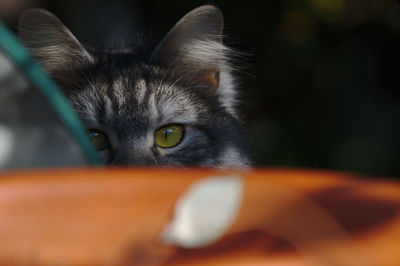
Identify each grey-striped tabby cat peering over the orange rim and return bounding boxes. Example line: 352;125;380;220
19;5;250;167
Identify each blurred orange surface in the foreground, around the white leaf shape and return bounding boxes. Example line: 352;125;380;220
0;168;400;266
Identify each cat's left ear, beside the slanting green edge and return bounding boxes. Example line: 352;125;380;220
19;9;93;76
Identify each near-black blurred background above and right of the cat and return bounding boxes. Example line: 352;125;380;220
0;0;400;177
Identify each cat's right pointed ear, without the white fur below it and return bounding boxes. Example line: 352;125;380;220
152;5;224;86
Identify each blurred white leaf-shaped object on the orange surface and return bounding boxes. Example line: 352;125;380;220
161;176;243;248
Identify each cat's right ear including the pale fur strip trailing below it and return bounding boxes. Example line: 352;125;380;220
152;5;237;116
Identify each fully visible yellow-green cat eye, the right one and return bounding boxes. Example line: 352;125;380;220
154;125;184;148
